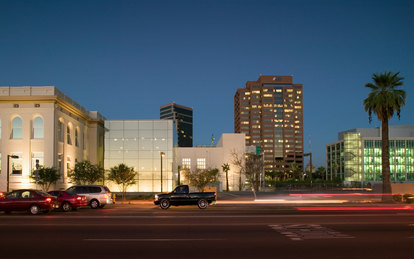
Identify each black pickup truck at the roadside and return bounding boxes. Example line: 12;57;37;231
154;185;217;210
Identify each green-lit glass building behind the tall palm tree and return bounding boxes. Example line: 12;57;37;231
326;126;414;183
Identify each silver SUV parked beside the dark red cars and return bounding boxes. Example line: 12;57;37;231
66;185;113;209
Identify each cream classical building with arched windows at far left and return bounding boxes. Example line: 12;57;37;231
0;86;105;191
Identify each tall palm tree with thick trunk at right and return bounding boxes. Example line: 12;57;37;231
364;72;406;202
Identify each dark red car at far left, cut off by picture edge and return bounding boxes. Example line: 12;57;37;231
0;189;59;215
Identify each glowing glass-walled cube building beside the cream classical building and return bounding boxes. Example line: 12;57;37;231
105;120;175;192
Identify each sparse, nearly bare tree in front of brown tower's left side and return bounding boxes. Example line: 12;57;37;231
245;154;264;200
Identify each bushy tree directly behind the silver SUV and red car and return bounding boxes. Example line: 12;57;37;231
69;160;105;184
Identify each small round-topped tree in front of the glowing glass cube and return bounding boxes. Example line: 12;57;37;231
108;164;137;200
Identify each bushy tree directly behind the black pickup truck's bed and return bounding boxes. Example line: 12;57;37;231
184;168;219;192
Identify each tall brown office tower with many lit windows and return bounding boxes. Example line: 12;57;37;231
234;76;303;171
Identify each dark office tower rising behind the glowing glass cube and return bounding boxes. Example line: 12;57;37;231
160;102;193;147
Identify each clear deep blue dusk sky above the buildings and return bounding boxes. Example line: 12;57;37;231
0;0;414;166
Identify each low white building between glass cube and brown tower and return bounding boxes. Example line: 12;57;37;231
177;133;246;191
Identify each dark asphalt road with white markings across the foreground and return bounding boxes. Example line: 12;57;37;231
0;203;414;259
